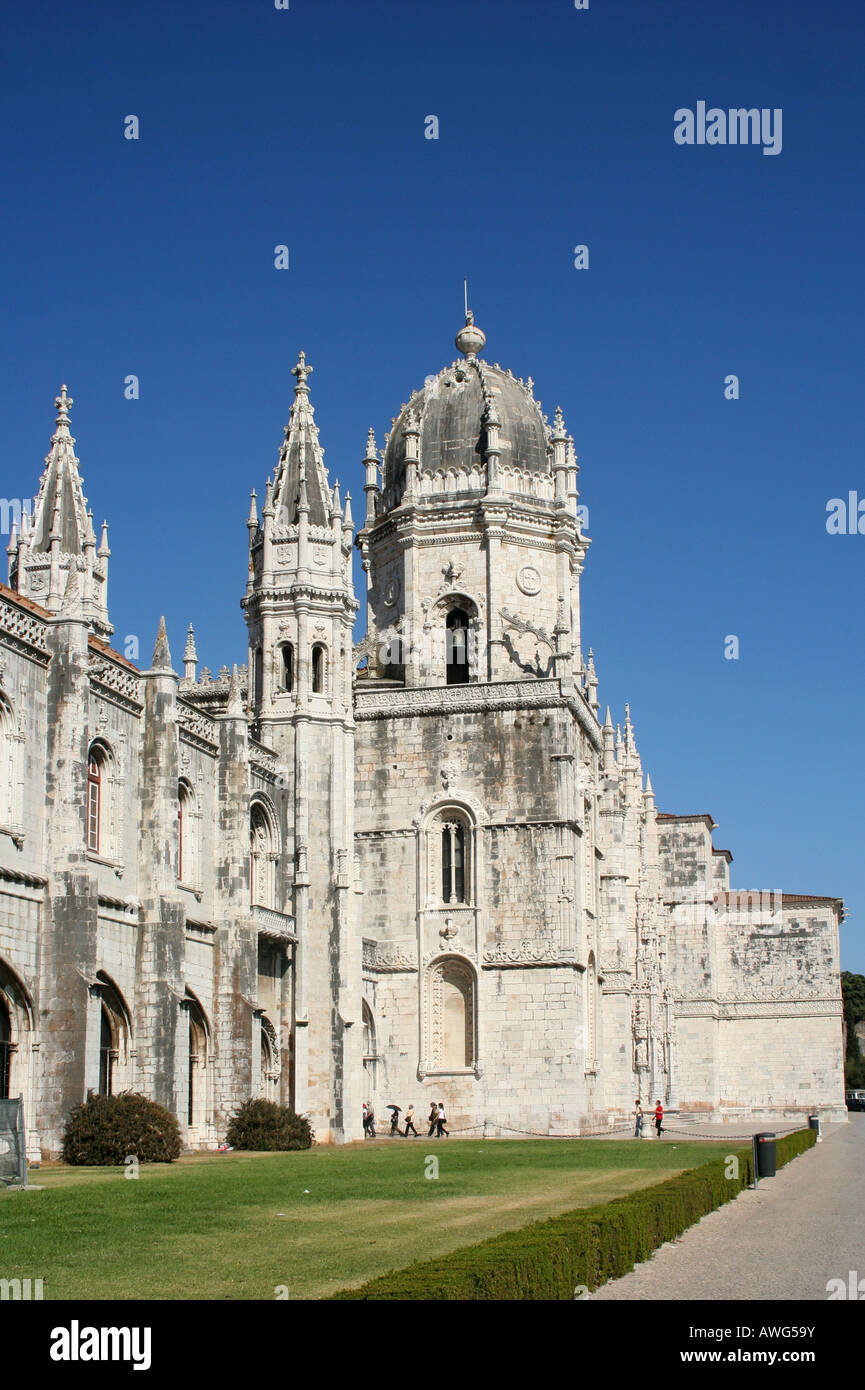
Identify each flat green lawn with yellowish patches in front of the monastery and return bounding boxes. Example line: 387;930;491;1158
0;1140;730;1300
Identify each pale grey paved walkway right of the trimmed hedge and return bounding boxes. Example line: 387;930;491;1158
590;1113;865;1302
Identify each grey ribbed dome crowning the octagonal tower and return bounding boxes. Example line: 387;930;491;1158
384;356;549;492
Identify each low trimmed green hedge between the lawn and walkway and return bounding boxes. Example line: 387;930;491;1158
332;1130;816;1301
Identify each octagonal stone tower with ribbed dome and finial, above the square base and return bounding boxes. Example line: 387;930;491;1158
357;306;588;689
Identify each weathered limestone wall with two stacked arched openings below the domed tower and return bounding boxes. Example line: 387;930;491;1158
356;685;604;1133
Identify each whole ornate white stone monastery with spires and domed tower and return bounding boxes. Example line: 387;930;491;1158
0;314;846;1156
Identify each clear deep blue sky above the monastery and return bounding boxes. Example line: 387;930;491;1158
0;0;865;970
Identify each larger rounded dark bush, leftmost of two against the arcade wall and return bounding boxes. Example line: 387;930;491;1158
63;1091;182;1166
